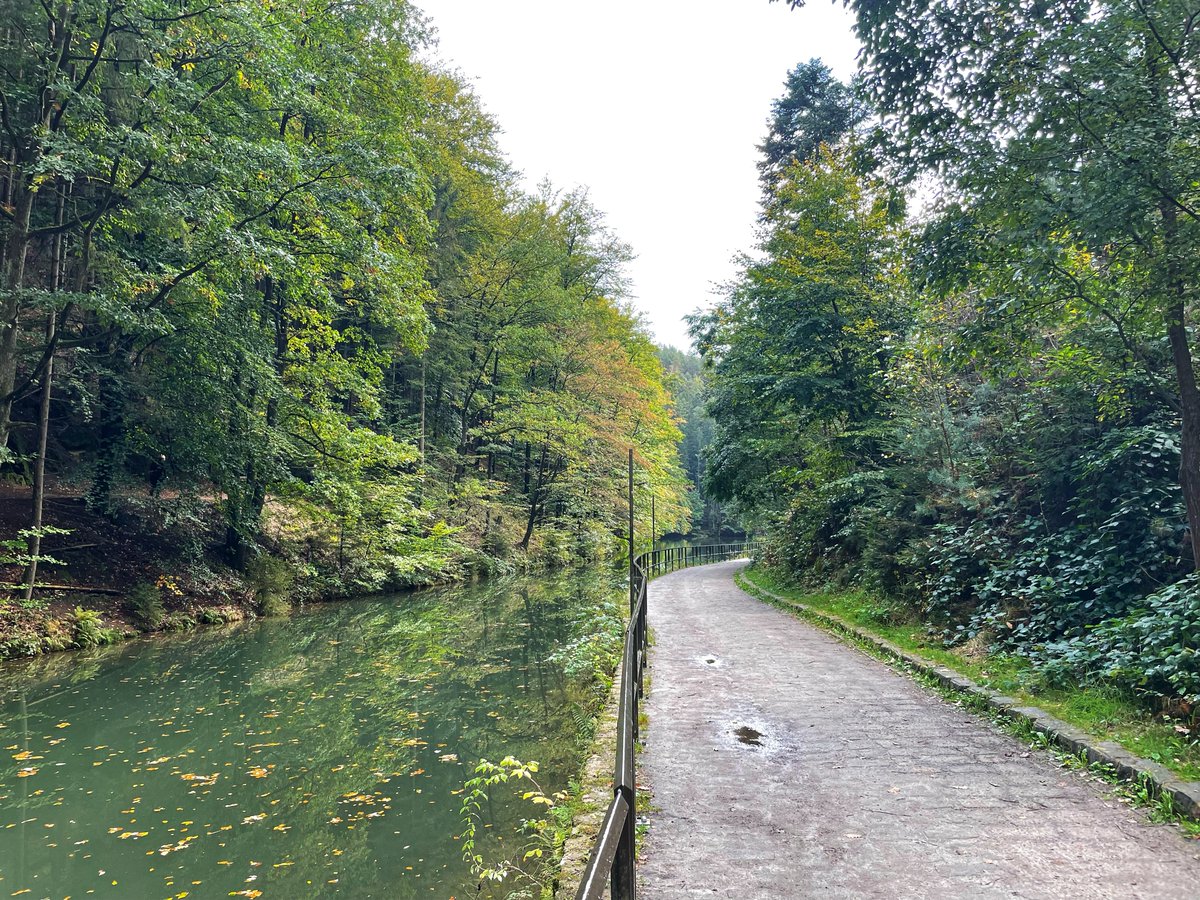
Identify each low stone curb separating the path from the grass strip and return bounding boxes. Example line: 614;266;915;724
748;583;1200;821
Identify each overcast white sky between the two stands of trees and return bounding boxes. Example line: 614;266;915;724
414;0;858;347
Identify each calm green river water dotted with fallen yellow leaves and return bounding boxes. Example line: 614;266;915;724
0;575;620;900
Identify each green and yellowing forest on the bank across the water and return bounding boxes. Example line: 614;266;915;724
0;0;691;655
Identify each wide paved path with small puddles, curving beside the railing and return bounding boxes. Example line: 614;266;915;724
638;563;1200;900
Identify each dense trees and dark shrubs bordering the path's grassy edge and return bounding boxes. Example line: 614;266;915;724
692;0;1200;730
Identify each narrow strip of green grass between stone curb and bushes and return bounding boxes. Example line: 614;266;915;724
746;568;1200;781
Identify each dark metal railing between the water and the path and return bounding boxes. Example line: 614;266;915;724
575;544;757;900
